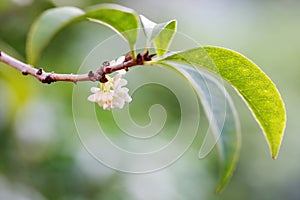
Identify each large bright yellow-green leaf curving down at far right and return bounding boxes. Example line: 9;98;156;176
161;46;286;159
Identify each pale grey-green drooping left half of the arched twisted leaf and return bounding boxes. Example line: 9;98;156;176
26;7;84;64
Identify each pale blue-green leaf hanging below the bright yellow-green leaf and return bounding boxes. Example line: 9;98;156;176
160;62;241;193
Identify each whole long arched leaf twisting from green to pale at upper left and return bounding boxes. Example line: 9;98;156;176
26;4;138;65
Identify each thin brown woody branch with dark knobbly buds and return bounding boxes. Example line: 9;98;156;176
0;50;155;84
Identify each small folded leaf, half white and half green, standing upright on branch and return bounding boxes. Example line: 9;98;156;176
140;15;177;56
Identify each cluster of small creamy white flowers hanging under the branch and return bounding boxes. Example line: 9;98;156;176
88;73;132;110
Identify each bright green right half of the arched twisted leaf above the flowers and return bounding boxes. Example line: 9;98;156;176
85;4;139;51
